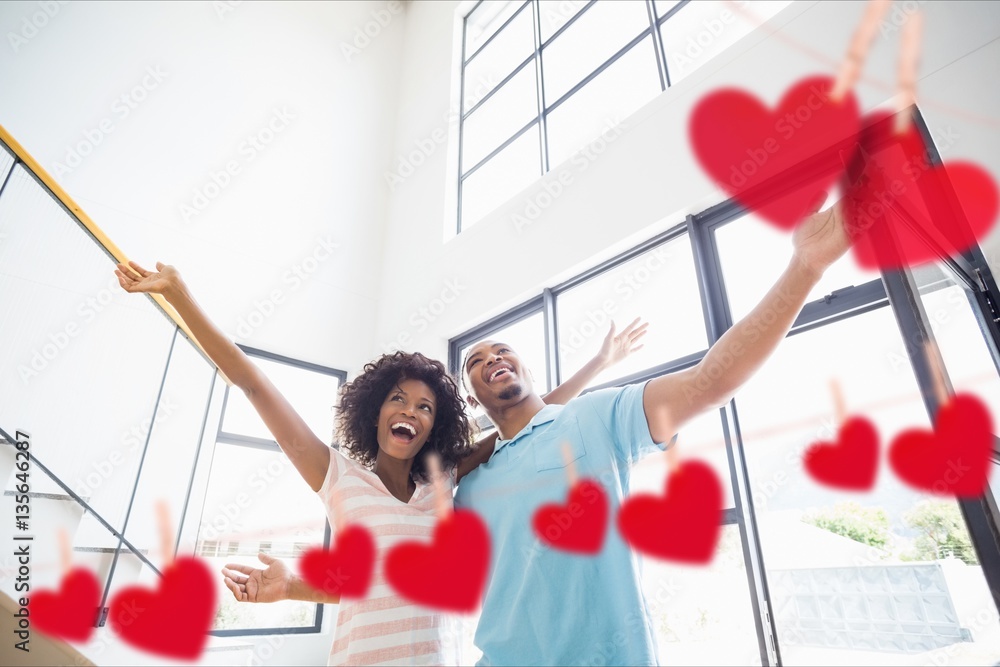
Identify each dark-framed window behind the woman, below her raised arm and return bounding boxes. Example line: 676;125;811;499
198;348;346;635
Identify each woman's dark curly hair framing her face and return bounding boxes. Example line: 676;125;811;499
337;352;473;481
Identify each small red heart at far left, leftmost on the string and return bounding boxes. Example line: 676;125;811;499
28;567;101;642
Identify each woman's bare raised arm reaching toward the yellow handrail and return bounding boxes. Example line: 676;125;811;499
115;262;330;491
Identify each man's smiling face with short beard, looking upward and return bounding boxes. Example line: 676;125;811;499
463;340;534;414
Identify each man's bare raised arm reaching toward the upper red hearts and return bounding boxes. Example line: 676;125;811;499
642;202;850;442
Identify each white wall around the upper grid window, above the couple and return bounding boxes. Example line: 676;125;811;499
371;1;1000;366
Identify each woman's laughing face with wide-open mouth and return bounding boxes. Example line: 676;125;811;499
378;380;437;460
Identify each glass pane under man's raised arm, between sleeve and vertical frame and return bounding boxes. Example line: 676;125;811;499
629;410;736;508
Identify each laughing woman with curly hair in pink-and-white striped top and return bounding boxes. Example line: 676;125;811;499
115;262;647;664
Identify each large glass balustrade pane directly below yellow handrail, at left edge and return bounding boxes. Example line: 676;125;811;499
0;165;175;529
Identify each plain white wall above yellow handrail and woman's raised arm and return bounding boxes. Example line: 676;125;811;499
0;2;405;370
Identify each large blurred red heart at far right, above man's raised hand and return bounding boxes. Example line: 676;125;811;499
845;114;1000;269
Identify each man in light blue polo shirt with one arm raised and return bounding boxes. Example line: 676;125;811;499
455;196;850;665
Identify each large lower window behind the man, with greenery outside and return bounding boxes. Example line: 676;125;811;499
449;108;1000;665
